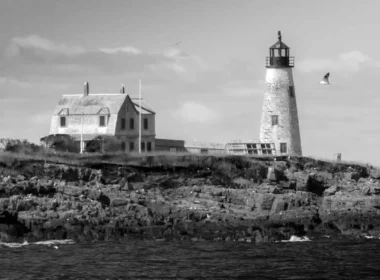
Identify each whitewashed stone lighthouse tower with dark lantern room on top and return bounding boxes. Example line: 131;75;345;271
260;31;302;156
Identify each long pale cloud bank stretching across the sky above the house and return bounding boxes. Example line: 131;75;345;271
0;35;214;84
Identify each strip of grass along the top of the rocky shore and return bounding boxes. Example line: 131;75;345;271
0;151;374;175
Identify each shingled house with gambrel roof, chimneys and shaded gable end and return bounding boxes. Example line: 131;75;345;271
49;83;156;152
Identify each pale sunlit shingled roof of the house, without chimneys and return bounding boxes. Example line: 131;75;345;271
53;93;155;115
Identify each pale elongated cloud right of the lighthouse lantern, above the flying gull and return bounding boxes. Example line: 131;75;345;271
297;50;375;72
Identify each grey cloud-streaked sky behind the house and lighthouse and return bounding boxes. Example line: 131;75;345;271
0;0;380;166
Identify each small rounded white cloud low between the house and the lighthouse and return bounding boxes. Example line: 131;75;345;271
176;101;219;124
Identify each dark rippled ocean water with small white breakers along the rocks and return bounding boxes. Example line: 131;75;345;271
0;237;380;279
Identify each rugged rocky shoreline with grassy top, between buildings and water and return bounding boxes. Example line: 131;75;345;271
0;156;380;243
